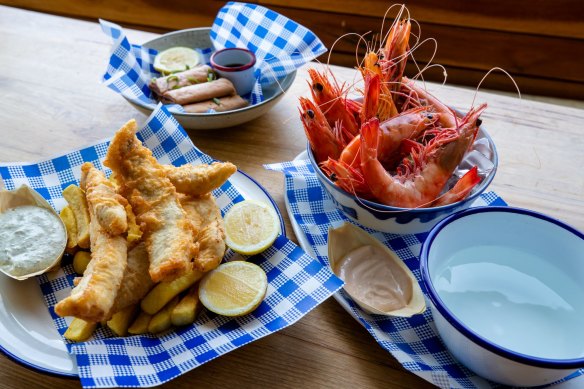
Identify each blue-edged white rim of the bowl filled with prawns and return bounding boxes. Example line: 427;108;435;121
306;119;499;213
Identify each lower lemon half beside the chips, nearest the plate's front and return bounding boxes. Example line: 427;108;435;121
199;261;268;316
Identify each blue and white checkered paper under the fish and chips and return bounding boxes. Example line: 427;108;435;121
0;106;342;388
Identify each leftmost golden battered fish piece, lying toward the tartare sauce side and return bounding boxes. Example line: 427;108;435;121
55;203;128;322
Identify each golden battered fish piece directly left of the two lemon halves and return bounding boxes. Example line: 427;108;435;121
181;193;226;272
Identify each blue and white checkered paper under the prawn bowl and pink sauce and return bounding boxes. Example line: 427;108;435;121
266;160;584;389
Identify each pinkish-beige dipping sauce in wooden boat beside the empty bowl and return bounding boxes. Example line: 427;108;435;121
337;245;413;312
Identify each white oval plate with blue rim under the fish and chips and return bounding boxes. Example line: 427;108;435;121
0;171;286;377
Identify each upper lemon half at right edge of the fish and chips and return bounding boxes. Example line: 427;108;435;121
224;200;280;255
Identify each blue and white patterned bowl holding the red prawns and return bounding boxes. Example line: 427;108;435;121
307;127;499;234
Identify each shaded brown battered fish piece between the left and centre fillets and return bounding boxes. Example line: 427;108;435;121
112;242;154;313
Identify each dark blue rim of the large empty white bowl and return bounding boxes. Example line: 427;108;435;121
420;206;584;369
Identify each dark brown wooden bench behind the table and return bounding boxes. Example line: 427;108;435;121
0;0;584;100
